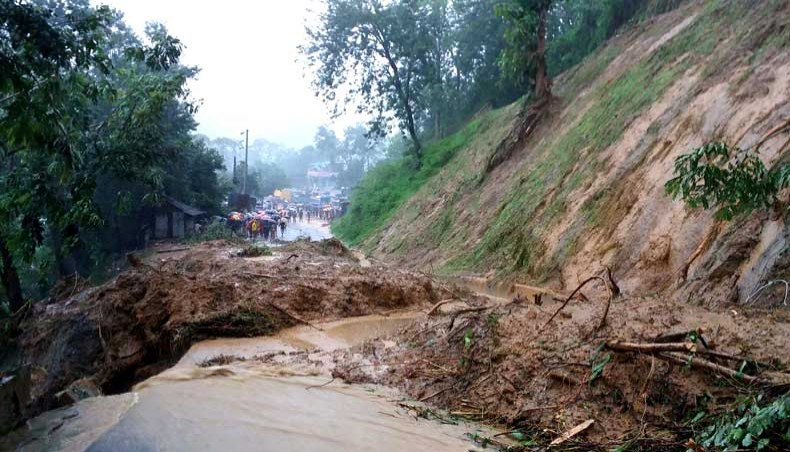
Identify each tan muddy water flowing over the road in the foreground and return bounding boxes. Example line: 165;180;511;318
9;313;496;451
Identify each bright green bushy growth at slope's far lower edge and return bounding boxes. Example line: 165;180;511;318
332;119;481;244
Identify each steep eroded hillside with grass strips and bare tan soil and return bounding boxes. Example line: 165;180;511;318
363;0;790;303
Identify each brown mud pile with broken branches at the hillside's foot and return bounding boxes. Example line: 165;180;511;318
335;282;790;450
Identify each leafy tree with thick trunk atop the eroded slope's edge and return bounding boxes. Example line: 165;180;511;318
496;0;554;103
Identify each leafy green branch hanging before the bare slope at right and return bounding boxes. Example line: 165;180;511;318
665;142;790;220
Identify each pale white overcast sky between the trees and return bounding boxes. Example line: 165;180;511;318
92;0;358;148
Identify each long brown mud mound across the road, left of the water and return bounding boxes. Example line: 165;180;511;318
15;242;447;415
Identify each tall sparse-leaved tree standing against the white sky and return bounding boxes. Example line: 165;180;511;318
301;0;434;165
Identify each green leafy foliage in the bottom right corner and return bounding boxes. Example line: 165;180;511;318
695;394;790;452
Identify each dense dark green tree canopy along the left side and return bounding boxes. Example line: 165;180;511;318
0;0;221;308
